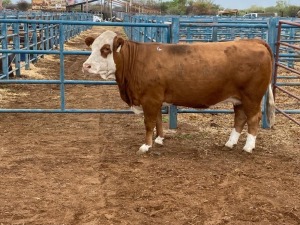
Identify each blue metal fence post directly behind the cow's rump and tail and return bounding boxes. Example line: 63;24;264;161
262;18;279;129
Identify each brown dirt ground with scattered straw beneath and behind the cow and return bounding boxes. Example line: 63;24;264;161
0;27;300;225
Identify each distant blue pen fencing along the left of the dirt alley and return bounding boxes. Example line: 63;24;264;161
0;12;92;78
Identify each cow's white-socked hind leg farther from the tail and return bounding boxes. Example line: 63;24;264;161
225;105;247;148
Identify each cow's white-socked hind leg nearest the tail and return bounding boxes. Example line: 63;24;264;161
243;104;261;153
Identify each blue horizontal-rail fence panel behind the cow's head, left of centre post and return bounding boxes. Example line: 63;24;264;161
0;19;170;116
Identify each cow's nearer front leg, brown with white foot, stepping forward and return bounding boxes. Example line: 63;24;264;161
137;104;160;154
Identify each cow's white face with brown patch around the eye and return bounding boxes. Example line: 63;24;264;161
82;31;117;80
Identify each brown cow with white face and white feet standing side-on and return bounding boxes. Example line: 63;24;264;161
83;31;275;153
